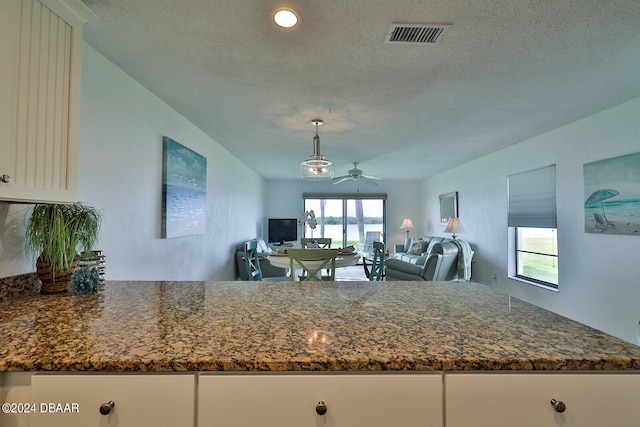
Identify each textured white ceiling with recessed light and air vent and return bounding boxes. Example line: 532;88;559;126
84;0;640;179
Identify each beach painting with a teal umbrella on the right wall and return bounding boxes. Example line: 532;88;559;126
584;153;640;236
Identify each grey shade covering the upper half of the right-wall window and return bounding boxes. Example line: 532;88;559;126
507;165;557;228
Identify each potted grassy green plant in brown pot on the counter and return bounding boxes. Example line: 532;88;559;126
26;202;102;293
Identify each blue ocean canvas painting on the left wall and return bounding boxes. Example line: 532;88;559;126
162;136;207;239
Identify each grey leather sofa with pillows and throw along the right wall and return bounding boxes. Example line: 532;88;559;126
384;236;473;281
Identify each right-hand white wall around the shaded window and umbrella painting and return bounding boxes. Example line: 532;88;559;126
421;98;640;343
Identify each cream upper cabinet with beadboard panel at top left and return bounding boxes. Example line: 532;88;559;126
0;0;97;201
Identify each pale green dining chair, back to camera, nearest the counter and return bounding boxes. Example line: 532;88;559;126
288;249;338;281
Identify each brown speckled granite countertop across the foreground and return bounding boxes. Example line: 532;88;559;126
0;281;640;372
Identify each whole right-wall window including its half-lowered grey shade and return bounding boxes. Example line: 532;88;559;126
507;165;558;290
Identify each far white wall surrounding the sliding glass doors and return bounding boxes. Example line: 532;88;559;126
263;179;423;247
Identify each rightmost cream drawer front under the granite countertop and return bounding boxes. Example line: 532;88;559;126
445;373;640;427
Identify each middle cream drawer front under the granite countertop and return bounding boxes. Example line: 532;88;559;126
198;374;442;427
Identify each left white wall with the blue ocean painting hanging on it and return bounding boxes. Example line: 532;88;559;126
0;44;264;280
